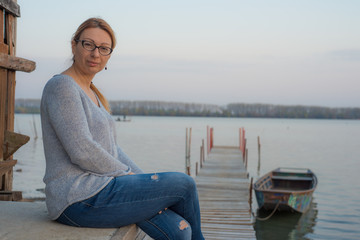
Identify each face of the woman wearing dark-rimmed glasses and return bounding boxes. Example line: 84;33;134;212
72;28;112;75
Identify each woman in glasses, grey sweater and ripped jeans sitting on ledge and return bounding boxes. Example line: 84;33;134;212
41;18;204;239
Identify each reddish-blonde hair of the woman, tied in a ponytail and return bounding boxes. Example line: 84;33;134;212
71;18;116;113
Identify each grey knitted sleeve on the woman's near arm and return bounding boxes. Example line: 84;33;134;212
42;80;131;176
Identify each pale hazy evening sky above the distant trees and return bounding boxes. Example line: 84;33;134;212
16;0;360;107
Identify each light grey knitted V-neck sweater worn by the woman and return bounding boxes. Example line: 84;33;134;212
41;75;142;219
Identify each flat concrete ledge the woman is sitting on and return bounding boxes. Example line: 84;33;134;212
0;201;151;240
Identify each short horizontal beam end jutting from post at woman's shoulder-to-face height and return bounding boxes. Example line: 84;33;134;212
0;53;36;72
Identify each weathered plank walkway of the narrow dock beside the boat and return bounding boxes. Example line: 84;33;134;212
195;146;256;240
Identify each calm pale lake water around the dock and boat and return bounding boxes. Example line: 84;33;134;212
14;114;360;239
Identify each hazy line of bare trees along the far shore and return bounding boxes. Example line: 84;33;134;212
15;99;360;119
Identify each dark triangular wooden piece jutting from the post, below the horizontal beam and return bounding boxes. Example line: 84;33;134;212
3;131;30;160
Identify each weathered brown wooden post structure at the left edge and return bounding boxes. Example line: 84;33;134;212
0;0;35;201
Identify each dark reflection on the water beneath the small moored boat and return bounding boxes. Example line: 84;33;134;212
254;201;318;240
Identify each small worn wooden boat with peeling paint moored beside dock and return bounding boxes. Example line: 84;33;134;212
254;168;318;213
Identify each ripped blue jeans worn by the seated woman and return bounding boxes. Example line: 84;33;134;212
56;172;204;240
